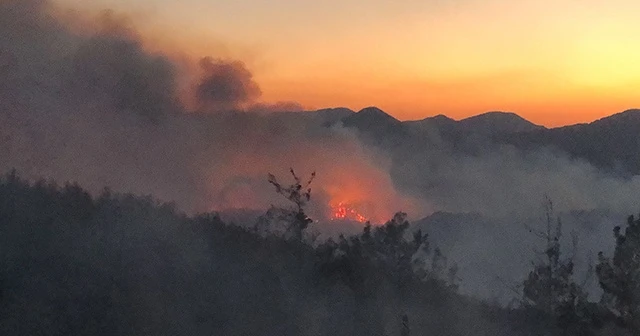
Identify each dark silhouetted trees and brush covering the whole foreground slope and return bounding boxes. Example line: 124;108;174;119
0;173;640;335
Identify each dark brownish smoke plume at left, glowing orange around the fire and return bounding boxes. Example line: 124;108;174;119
0;0;415;221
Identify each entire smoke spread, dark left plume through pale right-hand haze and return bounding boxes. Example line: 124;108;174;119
0;0;640;308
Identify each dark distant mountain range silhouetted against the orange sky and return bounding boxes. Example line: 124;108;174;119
298;107;640;175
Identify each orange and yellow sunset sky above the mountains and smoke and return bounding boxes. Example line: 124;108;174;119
57;0;640;126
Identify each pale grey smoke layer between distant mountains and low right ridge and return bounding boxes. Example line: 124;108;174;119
393;145;640;218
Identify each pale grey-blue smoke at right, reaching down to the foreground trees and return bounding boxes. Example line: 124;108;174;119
393;139;640;302
